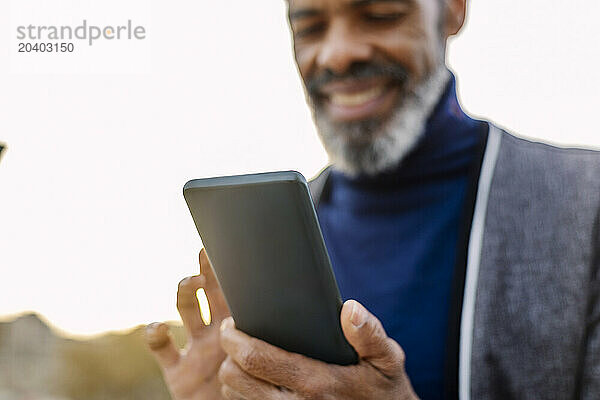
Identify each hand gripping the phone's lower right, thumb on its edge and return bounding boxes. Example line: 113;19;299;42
219;300;417;400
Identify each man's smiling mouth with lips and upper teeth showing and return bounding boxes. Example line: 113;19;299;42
320;79;399;122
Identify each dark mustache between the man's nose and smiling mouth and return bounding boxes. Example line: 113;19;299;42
306;63;408;98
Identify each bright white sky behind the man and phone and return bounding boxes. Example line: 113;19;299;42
0;0;600;335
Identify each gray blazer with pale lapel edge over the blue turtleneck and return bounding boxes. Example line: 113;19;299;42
311;125;600;400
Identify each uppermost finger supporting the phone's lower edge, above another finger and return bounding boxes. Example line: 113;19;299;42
221;318;330;393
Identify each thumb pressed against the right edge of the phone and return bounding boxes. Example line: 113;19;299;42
340;300;405;378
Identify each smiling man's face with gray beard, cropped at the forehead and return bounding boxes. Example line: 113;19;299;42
289;0;446;174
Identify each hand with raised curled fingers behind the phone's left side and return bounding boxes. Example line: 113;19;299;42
146;249;229;400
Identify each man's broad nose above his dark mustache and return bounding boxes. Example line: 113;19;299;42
317;23;373;74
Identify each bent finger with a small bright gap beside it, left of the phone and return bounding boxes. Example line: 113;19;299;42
177;275;206;338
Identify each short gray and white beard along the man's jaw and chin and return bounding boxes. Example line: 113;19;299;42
311;64;450;176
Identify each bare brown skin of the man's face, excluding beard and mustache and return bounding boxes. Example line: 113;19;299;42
289;0;466;122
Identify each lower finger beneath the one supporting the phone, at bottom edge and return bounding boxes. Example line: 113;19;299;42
219;357;282;400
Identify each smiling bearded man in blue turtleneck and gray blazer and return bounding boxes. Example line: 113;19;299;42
147;0;600;400
